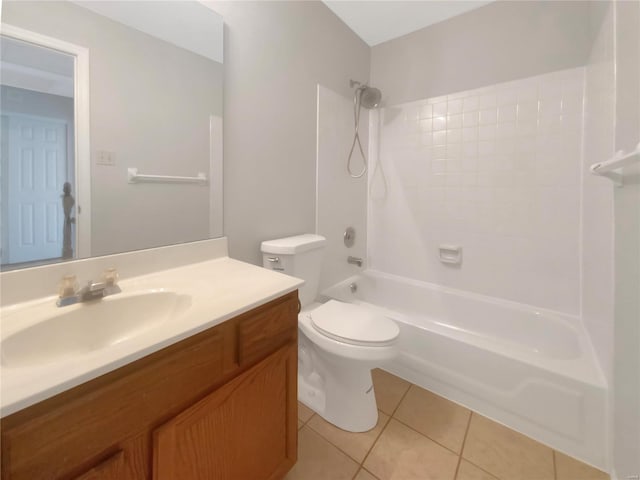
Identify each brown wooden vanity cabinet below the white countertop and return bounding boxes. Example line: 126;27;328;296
0;292;298;480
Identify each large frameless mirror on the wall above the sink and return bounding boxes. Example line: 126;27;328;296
0;1;223;270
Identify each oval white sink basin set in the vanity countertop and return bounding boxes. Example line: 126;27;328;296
0;290;191;367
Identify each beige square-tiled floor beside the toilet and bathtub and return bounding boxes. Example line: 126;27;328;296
285;370;609;480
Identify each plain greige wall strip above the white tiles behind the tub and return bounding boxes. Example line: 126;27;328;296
371;1;590;105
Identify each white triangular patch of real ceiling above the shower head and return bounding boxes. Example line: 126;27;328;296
323;0;493;46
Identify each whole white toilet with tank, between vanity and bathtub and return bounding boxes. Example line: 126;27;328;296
261;234;400;432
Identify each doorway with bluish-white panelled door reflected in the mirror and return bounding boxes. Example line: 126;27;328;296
0;38;75;265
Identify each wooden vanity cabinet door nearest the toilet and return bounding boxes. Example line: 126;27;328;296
153;343;297;480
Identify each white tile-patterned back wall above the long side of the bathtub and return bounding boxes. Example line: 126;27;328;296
367;67;585;314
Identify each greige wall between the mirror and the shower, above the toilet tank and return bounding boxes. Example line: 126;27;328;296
210;2;369;263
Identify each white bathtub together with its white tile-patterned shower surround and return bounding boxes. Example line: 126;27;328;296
317;67;609;470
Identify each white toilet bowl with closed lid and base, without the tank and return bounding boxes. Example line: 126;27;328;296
298;300;399;432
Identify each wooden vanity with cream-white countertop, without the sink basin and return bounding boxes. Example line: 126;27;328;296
0;244;301;480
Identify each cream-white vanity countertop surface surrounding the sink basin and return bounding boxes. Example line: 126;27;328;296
0;257;303;417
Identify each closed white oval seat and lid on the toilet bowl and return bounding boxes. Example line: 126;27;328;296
308;300;400;347
